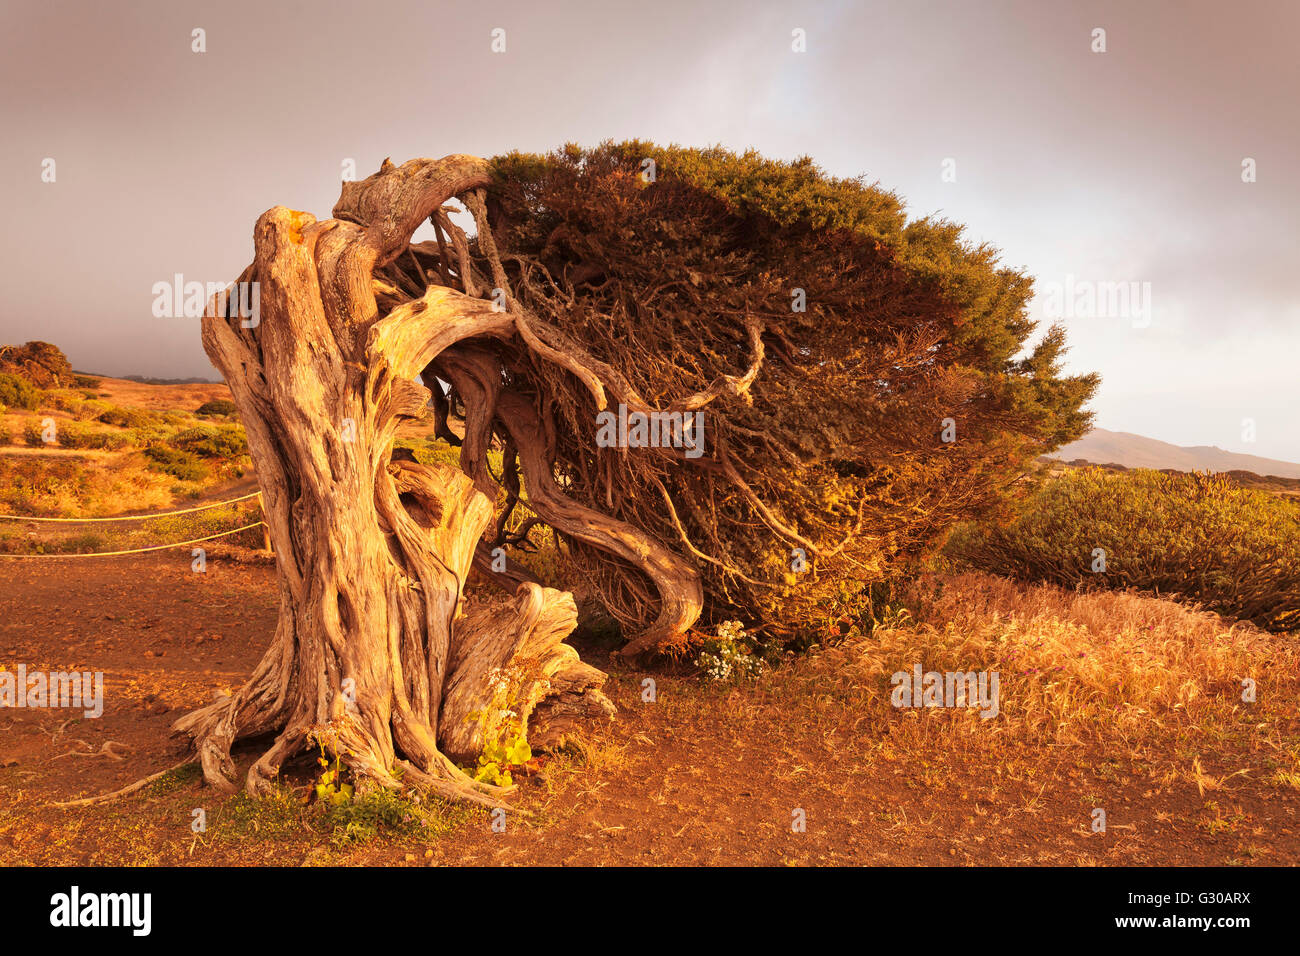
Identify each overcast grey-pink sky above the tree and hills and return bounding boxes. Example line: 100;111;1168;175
0;0;1300;460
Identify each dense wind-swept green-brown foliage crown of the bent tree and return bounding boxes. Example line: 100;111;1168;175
426;142;1097;642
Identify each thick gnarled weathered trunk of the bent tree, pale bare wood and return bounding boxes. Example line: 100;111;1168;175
176;156;612;804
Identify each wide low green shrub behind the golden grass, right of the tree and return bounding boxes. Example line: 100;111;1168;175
948;468;1300;631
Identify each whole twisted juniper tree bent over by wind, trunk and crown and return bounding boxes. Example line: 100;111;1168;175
177;143;1096;803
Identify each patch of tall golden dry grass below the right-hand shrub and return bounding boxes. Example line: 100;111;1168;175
780;572;1300;790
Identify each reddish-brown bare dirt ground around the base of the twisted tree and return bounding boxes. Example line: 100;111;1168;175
0;550;1300;865
